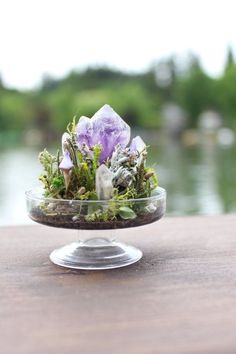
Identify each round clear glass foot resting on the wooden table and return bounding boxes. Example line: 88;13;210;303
50;237;143;270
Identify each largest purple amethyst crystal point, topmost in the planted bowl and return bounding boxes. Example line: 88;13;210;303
92;104;130;161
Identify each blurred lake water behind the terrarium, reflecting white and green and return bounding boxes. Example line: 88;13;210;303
0;143;236;225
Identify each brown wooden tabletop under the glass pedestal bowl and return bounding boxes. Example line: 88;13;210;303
0;215;236;354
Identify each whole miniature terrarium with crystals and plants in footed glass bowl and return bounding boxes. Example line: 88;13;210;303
26;105;166;269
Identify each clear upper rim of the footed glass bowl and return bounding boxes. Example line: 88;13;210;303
25;187;166;204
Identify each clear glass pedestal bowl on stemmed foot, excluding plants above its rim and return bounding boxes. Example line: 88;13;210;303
26;187;166;270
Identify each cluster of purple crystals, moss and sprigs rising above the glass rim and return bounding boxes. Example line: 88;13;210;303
39;104;157;200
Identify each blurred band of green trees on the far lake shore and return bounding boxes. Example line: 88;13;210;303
0;51;236;141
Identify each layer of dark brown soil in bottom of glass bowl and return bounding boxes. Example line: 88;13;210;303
30;207;164;230
